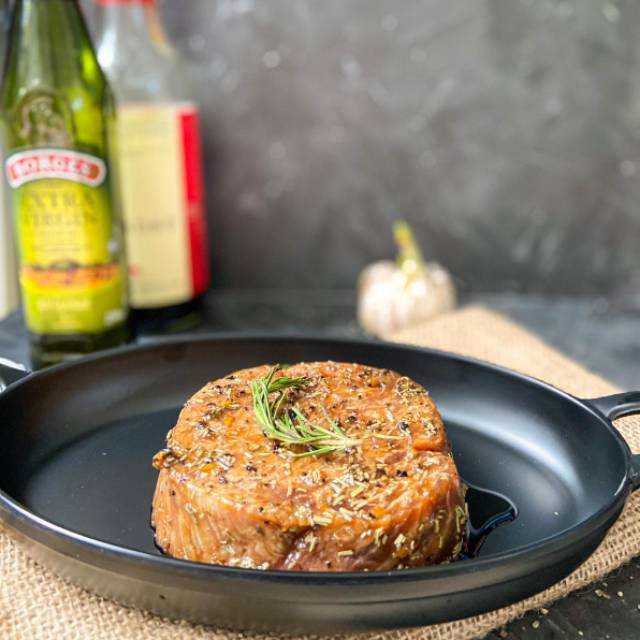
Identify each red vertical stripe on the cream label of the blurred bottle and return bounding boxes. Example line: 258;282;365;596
180;110;209;296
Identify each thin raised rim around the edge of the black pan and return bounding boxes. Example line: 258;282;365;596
0;332;631;600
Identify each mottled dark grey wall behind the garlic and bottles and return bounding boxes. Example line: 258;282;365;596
85;0;640;302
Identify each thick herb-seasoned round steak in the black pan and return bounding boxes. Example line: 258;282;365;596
152;362;467;571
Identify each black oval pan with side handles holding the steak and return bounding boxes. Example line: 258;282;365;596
0;336;640;633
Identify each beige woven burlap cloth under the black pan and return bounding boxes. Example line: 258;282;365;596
0;308;640;640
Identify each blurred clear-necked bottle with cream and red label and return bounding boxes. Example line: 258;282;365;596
96;0;209;333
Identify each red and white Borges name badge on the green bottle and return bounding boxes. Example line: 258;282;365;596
6;149;107;189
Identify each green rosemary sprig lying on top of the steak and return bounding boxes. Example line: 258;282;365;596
251;365;360;458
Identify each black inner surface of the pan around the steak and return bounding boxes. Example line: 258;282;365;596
0;339;625;556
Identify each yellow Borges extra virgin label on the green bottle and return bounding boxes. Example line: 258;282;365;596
5;149;126;335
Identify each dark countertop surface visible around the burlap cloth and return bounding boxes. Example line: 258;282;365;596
0;290;640;640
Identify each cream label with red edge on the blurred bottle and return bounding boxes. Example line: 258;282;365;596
117;102;208;308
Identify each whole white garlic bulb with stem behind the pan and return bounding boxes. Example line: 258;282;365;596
358;222;456;337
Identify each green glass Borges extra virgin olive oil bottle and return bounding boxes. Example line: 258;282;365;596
0;0;129;366
